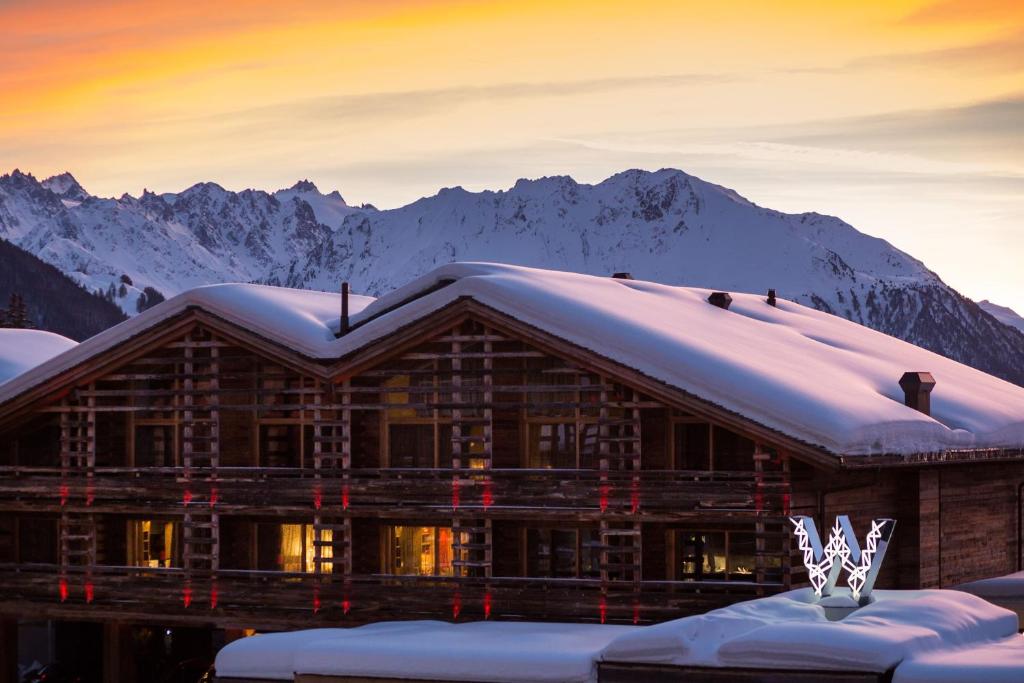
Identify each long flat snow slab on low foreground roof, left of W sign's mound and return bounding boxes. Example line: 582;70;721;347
215;622;638;683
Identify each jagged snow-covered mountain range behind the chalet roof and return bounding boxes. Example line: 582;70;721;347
6;169;1024;384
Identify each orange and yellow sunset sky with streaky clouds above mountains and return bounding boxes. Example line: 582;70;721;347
0;0;1024;312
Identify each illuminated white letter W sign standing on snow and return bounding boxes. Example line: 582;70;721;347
790;515;896;604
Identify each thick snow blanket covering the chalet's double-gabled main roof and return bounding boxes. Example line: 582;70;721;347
0;263;1024;456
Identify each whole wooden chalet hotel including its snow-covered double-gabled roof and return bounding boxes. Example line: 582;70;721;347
0;263;1024;681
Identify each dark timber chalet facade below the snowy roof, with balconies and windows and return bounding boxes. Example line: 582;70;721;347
0;300;1024;679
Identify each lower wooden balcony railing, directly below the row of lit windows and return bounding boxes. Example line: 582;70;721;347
0;564;782;629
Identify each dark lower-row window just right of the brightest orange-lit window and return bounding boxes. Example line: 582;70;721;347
525;528;601;579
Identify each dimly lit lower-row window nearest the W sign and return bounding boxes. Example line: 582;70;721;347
675;530;761;581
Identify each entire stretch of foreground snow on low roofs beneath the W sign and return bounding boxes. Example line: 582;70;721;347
216;589;1024;683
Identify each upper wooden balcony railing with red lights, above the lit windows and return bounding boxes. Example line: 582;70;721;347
0;467;790;521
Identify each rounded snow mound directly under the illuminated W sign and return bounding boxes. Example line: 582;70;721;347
603;588;1017;672
